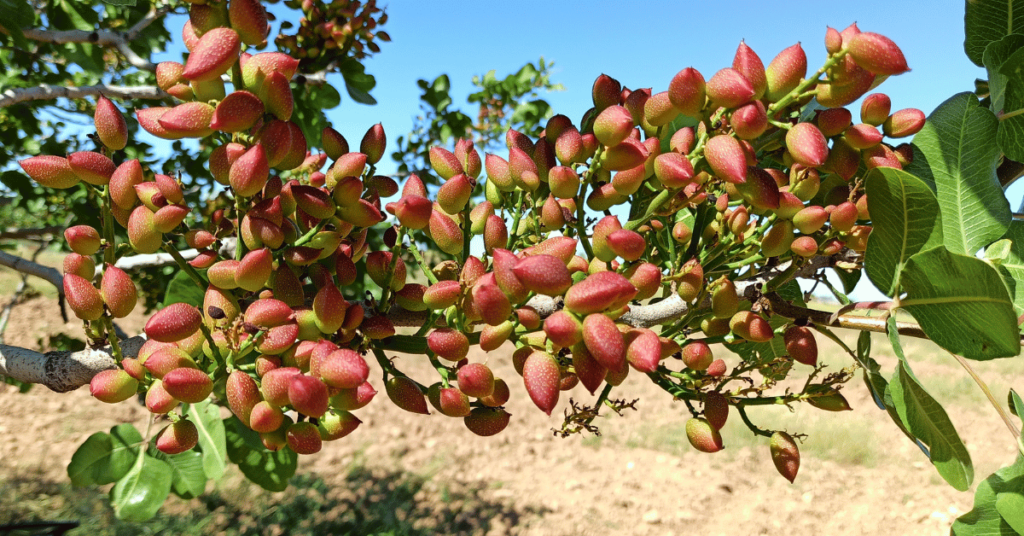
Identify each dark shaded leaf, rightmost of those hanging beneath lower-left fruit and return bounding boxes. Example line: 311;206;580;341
225;417;299;491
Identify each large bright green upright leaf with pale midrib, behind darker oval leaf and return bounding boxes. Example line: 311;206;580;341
913;92;1011;255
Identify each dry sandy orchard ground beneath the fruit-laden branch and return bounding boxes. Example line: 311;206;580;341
0;286;1024;536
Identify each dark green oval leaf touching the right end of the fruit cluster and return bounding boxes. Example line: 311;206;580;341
864;167;942;297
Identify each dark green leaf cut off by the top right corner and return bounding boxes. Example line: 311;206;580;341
964;0;1024;67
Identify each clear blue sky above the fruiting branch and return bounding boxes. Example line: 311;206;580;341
158;0;991;299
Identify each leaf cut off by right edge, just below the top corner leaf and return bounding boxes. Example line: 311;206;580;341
984;34;1024;161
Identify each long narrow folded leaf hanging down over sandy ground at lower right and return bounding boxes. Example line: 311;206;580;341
888;317;974;491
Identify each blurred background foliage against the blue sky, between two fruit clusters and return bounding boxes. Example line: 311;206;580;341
391;57;563;183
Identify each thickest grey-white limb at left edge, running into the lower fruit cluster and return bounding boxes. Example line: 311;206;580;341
0;337;145;393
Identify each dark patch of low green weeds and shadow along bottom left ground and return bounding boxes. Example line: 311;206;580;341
0;469;532;536
